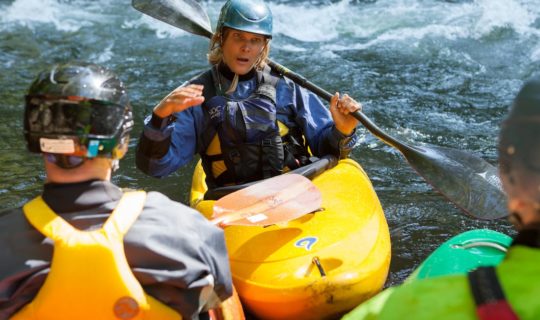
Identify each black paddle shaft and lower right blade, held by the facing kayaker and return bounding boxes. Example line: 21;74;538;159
267;59;507;220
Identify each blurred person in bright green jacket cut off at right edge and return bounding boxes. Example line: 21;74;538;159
343;78;540;320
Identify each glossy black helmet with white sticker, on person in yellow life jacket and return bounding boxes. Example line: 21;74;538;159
24;63;133;159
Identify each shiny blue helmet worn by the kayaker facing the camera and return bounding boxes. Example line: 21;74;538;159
216;0;272;38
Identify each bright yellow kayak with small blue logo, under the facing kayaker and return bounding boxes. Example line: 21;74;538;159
190;159;390;319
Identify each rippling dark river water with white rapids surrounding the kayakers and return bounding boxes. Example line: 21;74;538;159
0;0;540;300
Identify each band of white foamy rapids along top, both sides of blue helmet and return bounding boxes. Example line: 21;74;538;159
0;0;540;49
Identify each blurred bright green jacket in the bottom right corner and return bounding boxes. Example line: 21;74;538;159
343;235;540;320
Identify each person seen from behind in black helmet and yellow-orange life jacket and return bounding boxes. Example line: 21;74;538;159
0;63;232;319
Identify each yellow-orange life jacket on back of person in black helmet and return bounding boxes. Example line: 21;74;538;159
12;191;181;320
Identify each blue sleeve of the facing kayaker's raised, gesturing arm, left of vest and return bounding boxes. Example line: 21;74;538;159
136;106;206;177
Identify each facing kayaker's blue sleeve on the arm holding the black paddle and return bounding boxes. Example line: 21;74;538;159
277;79;357;158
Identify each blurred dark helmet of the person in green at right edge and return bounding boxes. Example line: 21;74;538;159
499;78;540;203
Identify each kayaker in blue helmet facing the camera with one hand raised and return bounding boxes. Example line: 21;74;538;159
137;0;361;188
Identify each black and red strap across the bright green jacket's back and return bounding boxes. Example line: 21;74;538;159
468;267;519;320
